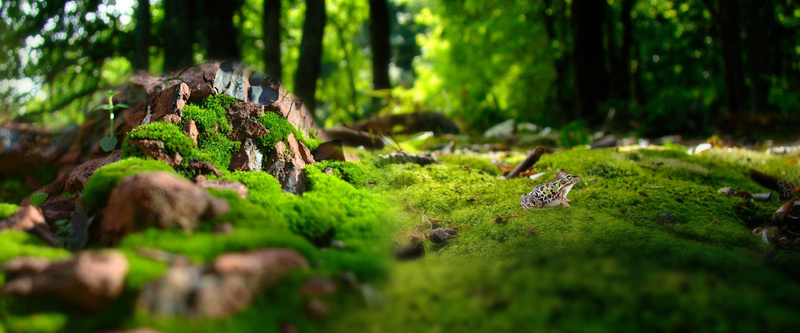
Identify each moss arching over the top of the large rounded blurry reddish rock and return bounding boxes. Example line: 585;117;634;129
83;157;175;209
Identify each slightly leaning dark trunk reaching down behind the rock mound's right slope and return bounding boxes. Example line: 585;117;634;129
294;0;325;116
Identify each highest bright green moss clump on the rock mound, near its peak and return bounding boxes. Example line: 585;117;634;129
181;95;239;134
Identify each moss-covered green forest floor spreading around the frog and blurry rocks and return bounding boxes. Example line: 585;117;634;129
0;134;800;332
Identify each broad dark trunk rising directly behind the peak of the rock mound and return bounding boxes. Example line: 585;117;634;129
201;0;244;61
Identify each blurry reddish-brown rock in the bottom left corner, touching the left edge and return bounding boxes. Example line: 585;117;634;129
0;250;128;310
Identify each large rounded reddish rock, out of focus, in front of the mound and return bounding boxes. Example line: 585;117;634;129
100;172;230;246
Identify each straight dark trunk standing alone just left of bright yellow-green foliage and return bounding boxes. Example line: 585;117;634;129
369;0;392;90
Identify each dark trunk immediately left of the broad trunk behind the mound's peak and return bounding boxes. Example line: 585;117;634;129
162;0;195;71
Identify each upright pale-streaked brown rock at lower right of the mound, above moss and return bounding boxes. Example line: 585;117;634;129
266;134;313;194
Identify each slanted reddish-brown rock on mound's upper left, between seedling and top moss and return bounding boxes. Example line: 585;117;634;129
125;82;191;133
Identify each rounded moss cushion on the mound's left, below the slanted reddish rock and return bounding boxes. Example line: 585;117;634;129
122;121;197;160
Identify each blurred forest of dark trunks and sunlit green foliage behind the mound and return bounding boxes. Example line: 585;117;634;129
0;0;800;136
